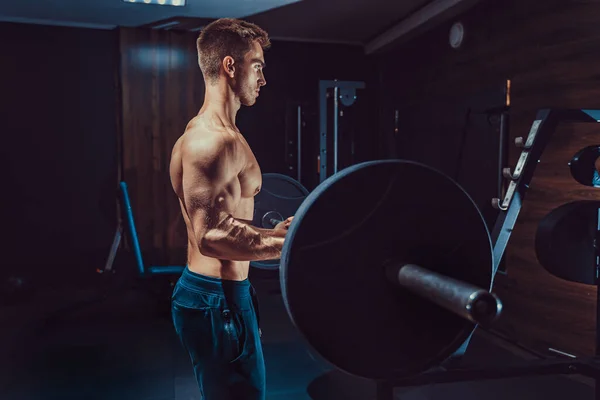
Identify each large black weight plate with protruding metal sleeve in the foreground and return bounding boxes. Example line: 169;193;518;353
260;160;502;379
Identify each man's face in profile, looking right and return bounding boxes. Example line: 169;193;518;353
235;42;267;106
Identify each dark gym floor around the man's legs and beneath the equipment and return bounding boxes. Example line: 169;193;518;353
0;270;594;400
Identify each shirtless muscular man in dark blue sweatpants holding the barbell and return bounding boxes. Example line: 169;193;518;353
170;18;291;400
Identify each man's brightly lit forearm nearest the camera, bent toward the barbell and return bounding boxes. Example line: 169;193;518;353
200;216;286;261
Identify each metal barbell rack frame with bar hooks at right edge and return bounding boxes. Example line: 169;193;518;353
377;109;600;400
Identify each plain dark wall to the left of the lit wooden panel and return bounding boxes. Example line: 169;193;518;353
0;23;118;283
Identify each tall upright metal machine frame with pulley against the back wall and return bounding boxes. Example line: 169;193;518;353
319;79;365;183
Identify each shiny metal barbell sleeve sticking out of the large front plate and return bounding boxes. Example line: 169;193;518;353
384;263;502;326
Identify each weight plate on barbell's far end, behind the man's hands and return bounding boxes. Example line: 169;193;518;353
250;173;308;269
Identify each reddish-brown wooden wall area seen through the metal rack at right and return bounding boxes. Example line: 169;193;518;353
496;124;600;354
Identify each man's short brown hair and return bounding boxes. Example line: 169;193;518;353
196;18;271;82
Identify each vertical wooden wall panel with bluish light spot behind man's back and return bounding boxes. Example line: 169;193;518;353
120;28;204;265
